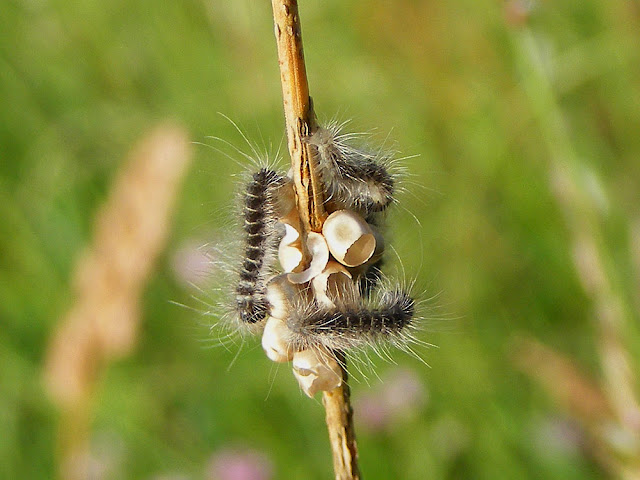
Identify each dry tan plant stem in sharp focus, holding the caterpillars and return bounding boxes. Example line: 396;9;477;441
271;0;360;480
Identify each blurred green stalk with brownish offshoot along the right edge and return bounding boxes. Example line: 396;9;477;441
513;28;640;480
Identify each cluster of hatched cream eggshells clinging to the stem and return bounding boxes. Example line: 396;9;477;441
262;200;384;397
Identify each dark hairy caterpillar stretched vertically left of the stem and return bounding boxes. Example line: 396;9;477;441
235;168;285;324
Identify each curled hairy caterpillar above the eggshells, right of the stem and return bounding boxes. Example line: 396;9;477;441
307;123;396;217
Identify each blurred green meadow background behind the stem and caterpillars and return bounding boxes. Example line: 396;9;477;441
0;0;640;480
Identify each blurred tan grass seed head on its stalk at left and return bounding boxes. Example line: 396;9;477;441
44;125;191;480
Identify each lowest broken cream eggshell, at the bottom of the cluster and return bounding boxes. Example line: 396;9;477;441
293;348;342;398
